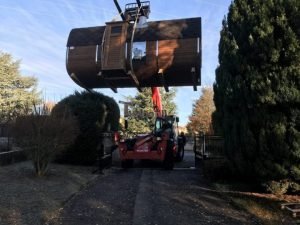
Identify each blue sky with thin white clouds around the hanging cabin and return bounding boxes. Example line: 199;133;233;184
0;0;231;125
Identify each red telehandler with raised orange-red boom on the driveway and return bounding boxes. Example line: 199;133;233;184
118;87;184;169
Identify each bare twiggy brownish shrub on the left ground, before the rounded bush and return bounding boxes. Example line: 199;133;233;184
14;105;79;176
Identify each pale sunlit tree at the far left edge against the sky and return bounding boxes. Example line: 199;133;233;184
0;52;40;123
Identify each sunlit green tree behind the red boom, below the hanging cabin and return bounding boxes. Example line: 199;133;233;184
123;88;176;135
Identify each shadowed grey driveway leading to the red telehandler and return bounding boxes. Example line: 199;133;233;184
50;152;259;225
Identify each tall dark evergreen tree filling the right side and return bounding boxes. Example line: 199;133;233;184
214;0;300;180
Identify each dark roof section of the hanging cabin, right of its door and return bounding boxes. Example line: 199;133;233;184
127;17;201;41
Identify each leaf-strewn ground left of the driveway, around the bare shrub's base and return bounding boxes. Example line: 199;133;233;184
0;161;97;225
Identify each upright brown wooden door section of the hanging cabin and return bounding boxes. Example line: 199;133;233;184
102;22;128;72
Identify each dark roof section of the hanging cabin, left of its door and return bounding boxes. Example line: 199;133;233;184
67;26;105;47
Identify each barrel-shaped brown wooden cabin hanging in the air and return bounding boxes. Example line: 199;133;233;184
66;18;201;91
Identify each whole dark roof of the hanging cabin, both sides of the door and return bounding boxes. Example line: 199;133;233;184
67;17;201;47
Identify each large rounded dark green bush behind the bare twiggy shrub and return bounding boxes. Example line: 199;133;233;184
52;91;120;165
